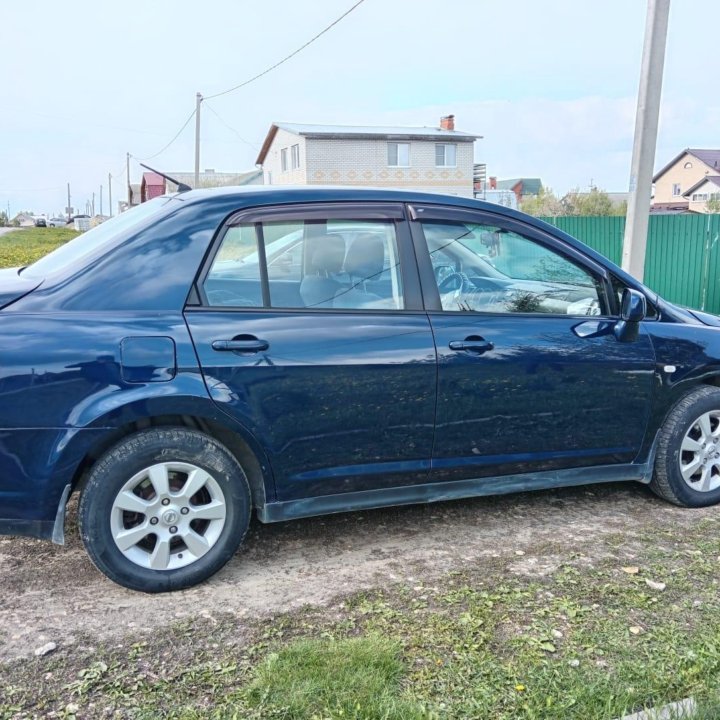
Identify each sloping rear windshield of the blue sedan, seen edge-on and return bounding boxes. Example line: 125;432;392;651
20;197;172;279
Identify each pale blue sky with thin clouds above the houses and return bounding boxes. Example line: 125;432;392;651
0;0;720;215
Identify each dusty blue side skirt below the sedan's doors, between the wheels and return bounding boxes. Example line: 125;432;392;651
257;462;653;523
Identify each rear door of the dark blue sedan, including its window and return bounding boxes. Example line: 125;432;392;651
185;203;436;500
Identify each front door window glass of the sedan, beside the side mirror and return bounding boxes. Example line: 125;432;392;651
422;222;604;315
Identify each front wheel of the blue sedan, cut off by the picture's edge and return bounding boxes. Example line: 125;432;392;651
650;386;720;508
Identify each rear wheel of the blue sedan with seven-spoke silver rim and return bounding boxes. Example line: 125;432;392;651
78;427;252;593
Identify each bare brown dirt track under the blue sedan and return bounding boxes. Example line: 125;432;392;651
0;484;718;661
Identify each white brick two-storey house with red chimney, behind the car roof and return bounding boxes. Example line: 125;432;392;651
257;115;481;197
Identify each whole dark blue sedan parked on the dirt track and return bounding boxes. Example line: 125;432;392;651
0;187;720;592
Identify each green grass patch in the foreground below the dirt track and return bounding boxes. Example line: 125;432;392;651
0;519;720;720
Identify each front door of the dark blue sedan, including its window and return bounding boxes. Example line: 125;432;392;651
413;207;654;480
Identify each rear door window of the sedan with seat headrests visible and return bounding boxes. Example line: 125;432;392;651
203;220;404;310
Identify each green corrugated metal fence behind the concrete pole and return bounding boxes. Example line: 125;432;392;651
543;214;720;314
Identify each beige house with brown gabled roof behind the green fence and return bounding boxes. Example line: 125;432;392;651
652;148;720;212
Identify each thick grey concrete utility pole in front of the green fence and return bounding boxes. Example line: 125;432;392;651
622;0;670;280
